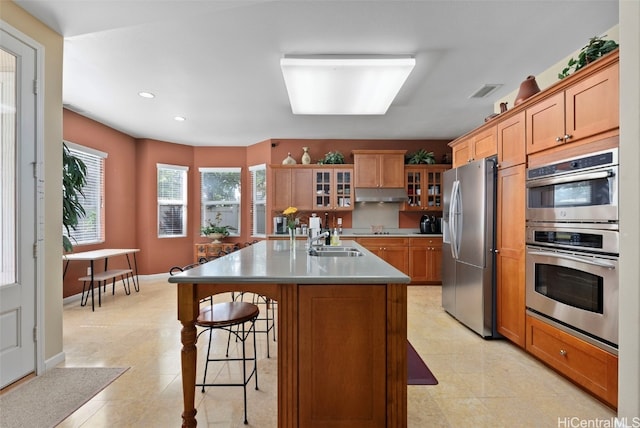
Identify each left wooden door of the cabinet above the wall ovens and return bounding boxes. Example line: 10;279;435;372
526;92;564;155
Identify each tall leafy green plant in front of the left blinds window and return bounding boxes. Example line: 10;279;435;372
62;142;87;252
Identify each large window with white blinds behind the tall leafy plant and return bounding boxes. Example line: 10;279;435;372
63;141;107;245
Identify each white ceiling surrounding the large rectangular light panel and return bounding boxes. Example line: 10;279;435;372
14;0;618;146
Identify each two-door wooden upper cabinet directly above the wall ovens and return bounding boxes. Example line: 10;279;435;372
526;52;620;154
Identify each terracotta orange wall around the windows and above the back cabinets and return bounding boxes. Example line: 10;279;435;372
63;110;450;297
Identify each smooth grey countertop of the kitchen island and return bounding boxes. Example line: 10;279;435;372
169;239;411;284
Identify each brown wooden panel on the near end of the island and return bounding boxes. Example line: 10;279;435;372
292;284;388;428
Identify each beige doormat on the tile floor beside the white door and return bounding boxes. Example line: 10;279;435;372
0;367;128;428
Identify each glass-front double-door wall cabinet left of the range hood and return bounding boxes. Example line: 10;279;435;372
312;166;353;211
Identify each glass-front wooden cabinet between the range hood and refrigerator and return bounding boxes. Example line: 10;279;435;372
404;165;450;211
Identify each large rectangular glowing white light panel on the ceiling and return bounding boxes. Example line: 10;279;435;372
280;55;415;115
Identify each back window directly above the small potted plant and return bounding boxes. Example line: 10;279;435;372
200;168;241;235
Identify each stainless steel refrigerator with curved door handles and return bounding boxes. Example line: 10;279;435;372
442;157;499;337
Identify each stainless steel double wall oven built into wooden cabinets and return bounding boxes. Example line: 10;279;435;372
526;148;619;352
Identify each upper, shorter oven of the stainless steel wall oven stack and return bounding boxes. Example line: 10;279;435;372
526;148;618;229
